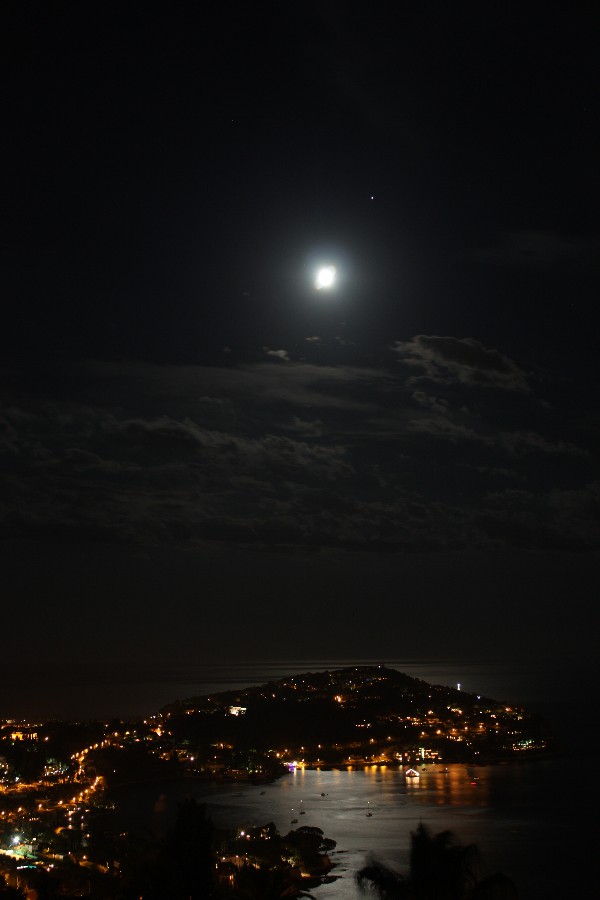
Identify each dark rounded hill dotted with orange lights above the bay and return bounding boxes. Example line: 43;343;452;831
161;666;553;763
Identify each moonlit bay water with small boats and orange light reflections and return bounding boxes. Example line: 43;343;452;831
119;759;591;900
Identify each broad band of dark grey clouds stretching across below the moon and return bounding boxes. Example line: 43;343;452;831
0;344;598;553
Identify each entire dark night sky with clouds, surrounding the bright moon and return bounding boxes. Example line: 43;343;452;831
0;2;600;696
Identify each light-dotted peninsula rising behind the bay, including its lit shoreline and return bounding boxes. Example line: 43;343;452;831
160;665;558;778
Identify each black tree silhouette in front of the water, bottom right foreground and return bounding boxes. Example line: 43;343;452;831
356;824;517;900
